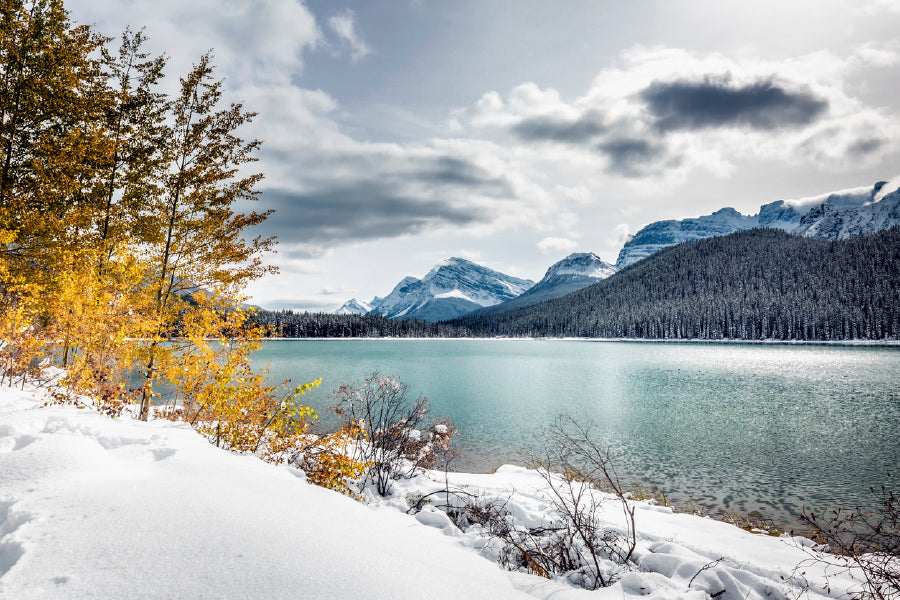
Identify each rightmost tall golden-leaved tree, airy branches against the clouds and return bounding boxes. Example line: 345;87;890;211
137;54;273;419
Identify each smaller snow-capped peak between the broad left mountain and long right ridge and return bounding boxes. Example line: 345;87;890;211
476;252;616;314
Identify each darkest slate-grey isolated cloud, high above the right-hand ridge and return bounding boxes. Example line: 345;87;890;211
640;78;828;132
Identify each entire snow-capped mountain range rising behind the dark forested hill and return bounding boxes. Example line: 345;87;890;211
336;179;900;323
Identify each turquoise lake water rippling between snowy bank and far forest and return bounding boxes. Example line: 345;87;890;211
254;340;900;525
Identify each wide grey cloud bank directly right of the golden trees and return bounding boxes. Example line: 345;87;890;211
253;153;516;247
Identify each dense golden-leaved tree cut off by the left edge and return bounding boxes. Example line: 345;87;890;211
0;0;105;390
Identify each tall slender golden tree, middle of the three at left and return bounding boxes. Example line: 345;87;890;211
42;29;168;390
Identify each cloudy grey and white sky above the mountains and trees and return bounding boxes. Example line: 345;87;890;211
67;0;900;310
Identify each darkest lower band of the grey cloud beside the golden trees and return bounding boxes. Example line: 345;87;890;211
258;186;484;244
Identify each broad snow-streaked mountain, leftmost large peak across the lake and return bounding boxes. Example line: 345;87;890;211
372;258;534;322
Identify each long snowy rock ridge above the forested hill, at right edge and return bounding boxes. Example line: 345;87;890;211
616;179;900;269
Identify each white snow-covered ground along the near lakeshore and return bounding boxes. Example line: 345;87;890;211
0;388;853;600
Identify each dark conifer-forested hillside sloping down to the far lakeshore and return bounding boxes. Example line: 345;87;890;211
451;227;900;340
